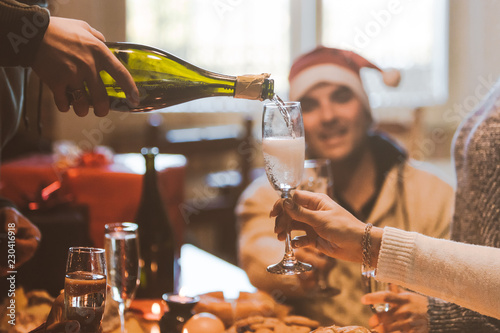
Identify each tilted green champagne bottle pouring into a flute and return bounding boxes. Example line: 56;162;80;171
100;42;274;112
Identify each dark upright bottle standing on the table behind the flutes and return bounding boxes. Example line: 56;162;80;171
135;147;179;298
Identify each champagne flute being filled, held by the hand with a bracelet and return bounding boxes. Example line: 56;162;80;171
262;102;312;275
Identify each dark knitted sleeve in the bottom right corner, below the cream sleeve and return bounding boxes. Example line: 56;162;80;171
427;298;500;333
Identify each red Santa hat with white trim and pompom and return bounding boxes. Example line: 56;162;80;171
288;46;401;110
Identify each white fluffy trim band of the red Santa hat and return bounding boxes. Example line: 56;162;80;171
290;64;370;110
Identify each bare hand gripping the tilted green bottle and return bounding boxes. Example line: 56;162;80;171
32;17;139;117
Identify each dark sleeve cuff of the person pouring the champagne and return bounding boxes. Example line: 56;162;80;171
0;0;50;66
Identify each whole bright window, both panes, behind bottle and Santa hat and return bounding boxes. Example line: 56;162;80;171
127;0;448;112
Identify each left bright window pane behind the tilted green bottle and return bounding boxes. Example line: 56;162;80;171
127;0;291;112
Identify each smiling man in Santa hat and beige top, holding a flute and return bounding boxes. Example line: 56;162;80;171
236;47;453;326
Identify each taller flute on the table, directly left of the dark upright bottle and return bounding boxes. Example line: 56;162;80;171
104;222;139;333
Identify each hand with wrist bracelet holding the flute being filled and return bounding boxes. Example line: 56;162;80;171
270;191;383;267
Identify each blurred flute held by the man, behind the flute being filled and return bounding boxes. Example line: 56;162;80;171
299;158;340;297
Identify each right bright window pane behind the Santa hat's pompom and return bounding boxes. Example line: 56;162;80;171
322;0;448;108
